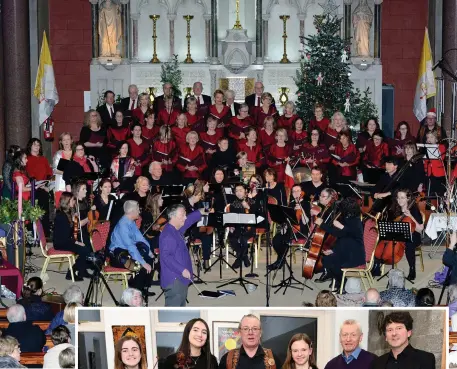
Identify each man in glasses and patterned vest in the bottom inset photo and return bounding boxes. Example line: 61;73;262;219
219;314;282;369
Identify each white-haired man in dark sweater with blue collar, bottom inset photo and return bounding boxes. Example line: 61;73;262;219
325;319;377;369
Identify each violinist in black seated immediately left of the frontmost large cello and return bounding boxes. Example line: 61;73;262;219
267;185;311;270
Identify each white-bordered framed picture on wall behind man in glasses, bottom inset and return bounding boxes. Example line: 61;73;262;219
212;321;241;361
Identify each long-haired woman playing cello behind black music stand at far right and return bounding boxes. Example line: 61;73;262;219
371;188;424;280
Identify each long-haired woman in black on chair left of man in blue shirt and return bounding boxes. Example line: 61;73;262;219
53;192;90;282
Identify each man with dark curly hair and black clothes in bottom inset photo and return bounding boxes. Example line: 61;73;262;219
371;311;435;369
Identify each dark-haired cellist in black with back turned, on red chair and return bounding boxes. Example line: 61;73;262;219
314;197;365;291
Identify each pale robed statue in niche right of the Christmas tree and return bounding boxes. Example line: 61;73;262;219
352;0;373;57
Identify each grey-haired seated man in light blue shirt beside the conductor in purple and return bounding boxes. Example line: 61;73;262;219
109;200;155;298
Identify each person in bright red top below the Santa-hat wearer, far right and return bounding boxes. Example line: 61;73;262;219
424;132;446;196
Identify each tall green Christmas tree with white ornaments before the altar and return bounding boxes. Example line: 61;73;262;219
294;15;377;137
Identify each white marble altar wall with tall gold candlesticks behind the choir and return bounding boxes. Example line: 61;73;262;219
90;0;382;121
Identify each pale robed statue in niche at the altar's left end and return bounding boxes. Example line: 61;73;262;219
98;0;122;57
